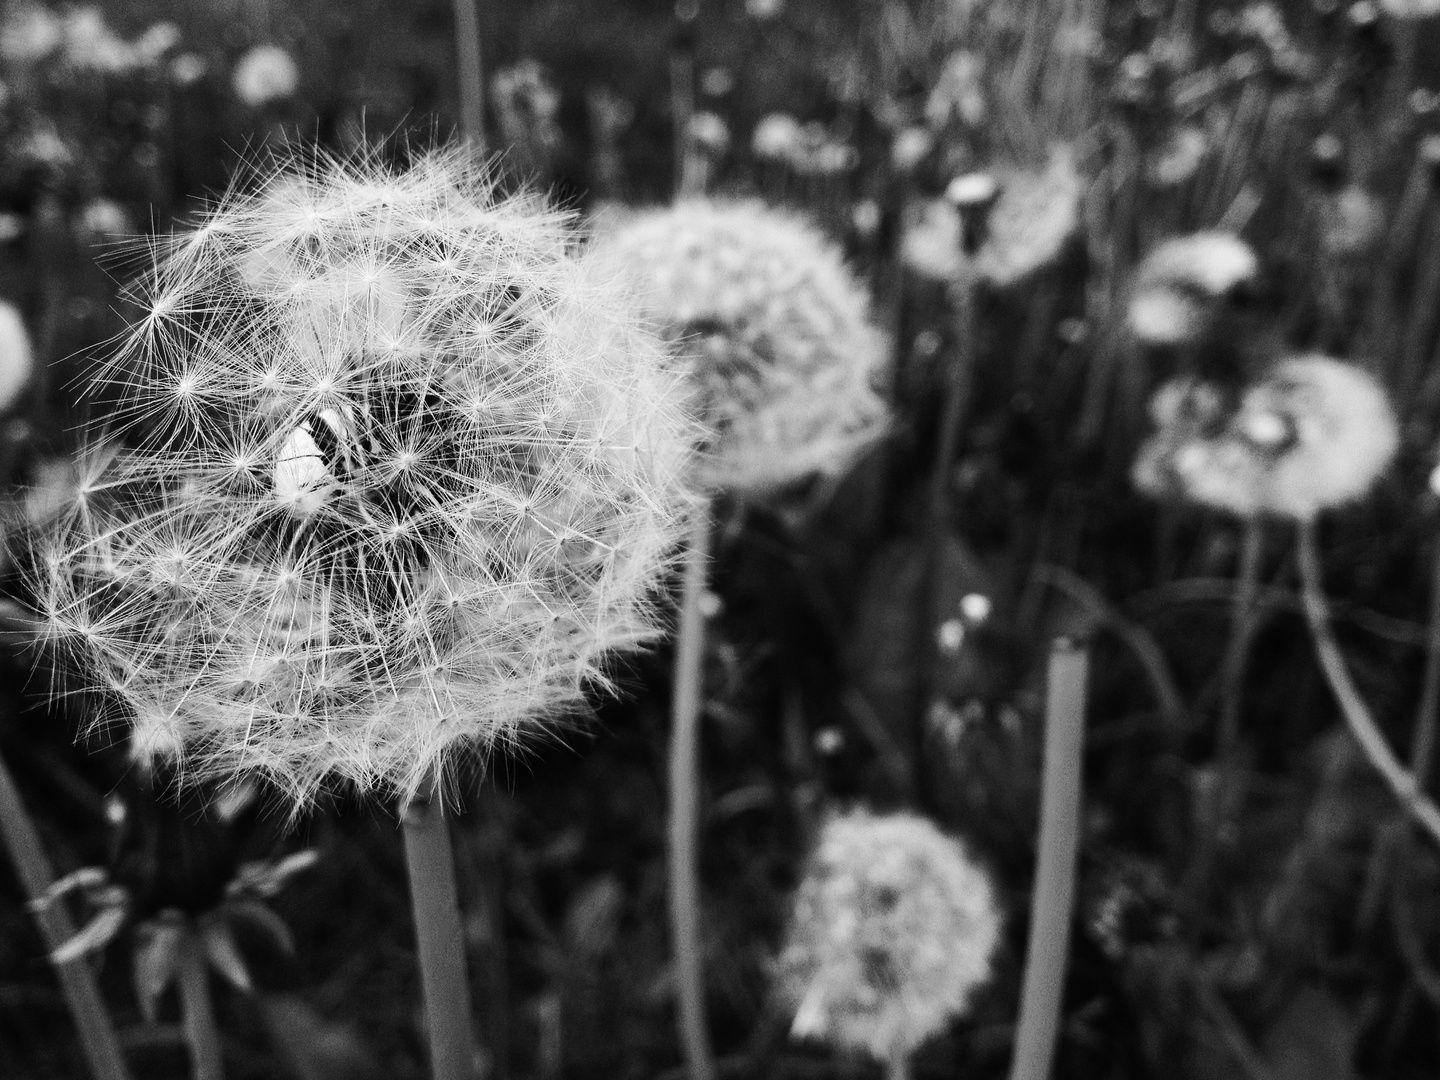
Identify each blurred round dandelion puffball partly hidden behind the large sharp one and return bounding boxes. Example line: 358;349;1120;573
595;200;887;495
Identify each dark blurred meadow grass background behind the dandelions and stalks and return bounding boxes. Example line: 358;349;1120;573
0;0;1440;1080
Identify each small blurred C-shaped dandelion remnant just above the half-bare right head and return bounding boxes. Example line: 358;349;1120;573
1126;230;1260;346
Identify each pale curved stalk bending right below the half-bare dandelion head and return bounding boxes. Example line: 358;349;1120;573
1297;521;1440;842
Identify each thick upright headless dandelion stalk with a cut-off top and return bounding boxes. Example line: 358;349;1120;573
1009;638;1090;1080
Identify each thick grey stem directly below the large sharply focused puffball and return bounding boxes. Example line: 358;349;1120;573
403;785;475;1080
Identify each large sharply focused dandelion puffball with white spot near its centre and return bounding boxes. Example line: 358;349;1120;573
33;154;694;805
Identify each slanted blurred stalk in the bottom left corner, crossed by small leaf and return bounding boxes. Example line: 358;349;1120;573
0;759;130;1080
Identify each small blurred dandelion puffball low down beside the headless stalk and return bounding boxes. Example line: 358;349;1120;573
779;811;1002;1061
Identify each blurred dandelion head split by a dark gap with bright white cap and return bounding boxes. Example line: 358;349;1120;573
900;145;1084;288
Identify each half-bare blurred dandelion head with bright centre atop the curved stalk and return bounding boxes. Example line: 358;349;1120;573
1133;356;1400;520
